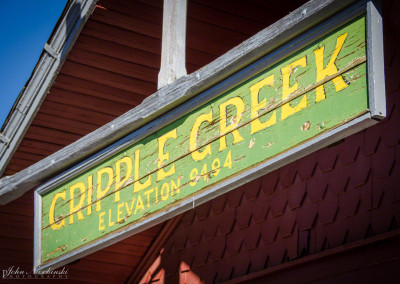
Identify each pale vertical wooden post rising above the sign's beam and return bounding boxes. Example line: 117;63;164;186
158;0;187;89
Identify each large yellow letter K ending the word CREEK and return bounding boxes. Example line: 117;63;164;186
314;33;348;102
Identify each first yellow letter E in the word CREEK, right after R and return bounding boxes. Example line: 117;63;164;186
250;74;276;134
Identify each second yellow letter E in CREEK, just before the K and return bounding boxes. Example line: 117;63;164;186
281;56;307;120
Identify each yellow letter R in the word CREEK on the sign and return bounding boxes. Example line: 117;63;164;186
218;97;244;151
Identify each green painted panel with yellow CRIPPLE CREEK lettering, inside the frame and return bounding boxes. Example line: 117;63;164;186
40;16;368;264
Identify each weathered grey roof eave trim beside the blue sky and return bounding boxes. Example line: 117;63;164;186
0;0;97;176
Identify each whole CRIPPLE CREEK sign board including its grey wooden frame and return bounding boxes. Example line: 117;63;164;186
35;1;384;269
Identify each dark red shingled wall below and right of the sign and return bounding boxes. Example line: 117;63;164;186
143;1;400;283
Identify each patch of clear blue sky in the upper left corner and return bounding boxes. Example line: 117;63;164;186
0;0;67;126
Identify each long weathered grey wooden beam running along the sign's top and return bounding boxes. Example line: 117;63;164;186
0;0;354;204
